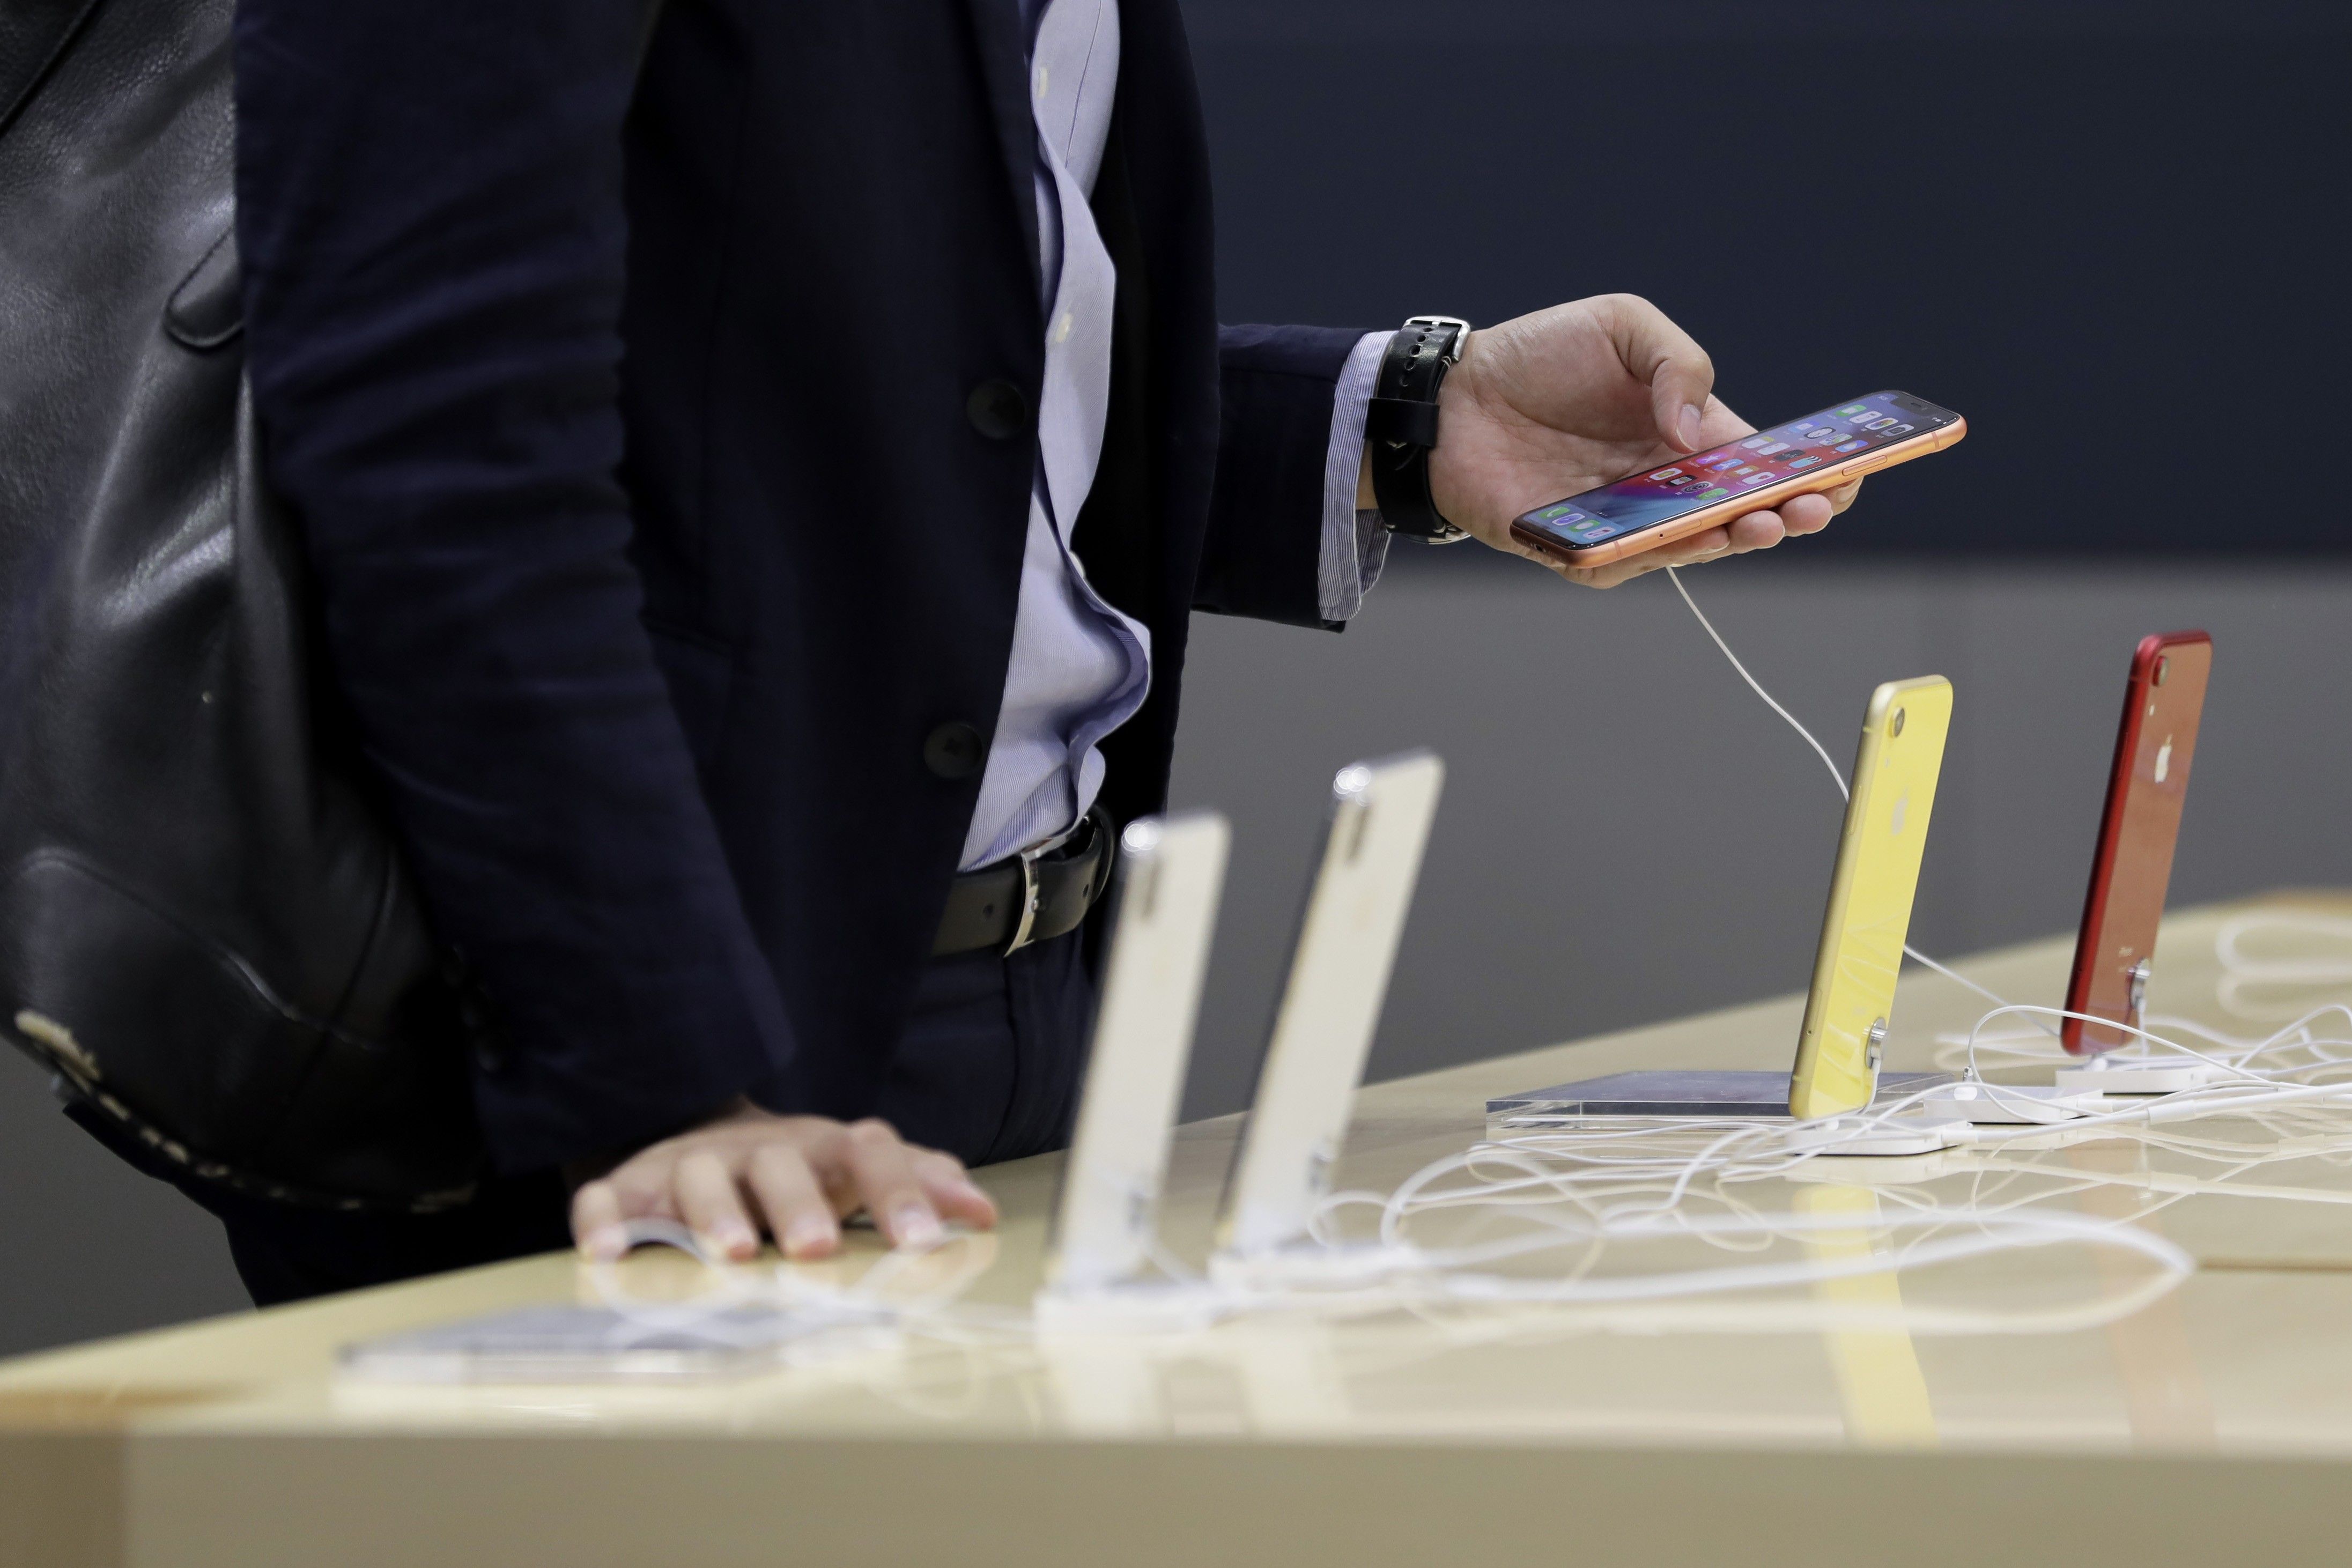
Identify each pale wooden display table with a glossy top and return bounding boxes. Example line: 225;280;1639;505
0;903;2352;1568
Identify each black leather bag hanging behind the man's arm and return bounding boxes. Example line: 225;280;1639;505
0;0;482;1208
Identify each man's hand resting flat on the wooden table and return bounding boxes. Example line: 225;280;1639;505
572;1100;997;1260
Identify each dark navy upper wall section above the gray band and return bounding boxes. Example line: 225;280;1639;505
1186;0;2352;555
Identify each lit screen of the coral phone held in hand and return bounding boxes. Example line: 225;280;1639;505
1519;393;1959;545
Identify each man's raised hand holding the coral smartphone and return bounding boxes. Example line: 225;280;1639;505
1402;294;1860;588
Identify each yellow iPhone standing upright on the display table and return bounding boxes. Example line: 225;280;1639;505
1787;675;1952;1119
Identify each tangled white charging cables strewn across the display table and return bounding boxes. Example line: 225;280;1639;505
569;580;2352;1345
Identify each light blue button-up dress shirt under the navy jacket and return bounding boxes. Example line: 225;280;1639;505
962;0;1390;870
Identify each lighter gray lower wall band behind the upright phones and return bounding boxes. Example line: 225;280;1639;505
1176;550;2352;1114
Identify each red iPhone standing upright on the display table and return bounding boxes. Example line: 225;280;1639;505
2058;632;2213;1055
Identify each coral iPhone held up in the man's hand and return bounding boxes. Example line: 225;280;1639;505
1510;393;1969;566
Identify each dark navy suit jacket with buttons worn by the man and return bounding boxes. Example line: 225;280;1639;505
235;0;1357;1168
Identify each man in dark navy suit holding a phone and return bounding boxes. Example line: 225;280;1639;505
221;0;1844;1300
